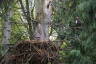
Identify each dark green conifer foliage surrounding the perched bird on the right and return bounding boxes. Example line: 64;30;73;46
55;0;96;64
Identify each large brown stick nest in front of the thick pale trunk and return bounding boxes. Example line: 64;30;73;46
2;40;57;64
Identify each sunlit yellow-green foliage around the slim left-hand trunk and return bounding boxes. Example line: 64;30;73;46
0;0;29;44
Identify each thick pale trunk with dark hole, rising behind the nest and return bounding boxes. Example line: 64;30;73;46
35;0;52;41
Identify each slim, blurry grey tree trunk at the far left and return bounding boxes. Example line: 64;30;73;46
2;6;12;51
